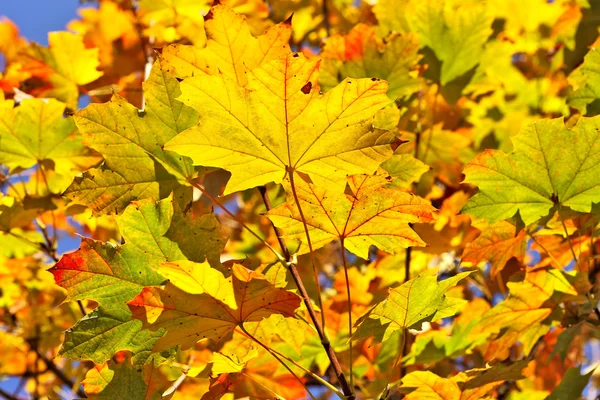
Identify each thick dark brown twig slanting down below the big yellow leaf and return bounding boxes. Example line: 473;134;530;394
259;187;355;400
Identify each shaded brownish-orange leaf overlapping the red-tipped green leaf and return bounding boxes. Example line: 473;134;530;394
128;264;300;351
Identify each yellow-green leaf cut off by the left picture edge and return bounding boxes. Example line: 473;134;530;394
0;99;101;174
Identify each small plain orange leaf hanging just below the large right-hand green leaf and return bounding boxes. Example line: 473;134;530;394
462;221;526;277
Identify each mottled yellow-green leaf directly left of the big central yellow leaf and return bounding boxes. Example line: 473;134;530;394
66;60;198;214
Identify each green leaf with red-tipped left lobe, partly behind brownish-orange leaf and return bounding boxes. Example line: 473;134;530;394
49;198;224;364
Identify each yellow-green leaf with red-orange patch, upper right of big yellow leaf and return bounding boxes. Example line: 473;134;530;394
319;24;422;100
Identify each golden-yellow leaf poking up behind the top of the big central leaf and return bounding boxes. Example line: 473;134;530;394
163;5;292;86
